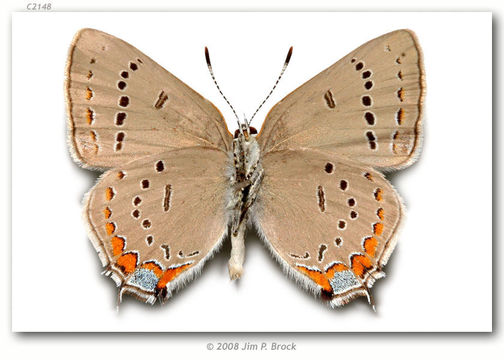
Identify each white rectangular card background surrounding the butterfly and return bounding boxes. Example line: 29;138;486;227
12;13;492;332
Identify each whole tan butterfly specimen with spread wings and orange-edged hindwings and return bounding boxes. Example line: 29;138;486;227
66;29;425;307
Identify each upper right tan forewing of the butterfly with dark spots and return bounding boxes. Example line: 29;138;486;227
258;30;425;169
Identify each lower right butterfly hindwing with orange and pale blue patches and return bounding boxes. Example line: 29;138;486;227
252;149;401;306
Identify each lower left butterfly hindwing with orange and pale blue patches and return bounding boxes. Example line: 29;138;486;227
84;147;228;303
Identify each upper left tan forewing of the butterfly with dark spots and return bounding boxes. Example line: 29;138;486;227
66;29;232;168
